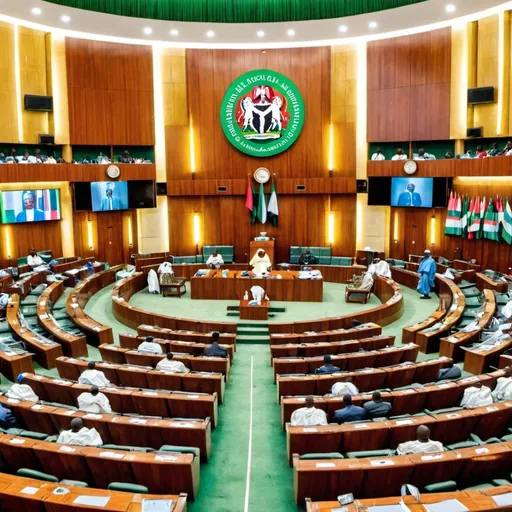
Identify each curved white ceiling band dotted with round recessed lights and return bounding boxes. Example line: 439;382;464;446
0;0;512;49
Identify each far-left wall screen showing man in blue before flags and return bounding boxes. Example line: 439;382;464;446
0;188;61;224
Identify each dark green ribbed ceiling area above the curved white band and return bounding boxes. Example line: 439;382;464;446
45;0;426;23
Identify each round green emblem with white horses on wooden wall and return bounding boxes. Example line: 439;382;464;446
220;69;304;157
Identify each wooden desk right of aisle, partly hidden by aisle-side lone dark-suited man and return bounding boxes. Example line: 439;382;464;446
273;343;419;382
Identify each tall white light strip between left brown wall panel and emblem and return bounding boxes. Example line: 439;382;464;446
153;45;167;182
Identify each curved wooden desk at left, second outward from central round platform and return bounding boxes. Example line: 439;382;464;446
37;281;88;357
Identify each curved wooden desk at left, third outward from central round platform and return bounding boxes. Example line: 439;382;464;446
7;294;62;368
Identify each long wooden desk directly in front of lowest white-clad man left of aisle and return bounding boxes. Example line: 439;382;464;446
0;396;211;460
